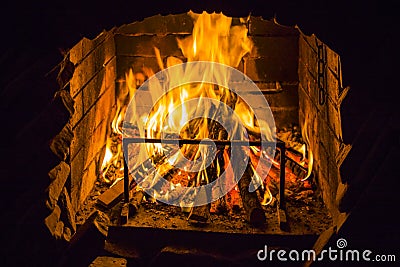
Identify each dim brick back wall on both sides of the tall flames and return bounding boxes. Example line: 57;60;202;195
115;14;299;128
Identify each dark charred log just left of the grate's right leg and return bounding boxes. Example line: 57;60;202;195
238;164;266;226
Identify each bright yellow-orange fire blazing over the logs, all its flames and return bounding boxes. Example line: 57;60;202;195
101;12;313;211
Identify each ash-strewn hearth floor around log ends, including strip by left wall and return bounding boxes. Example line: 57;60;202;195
77;180;332;235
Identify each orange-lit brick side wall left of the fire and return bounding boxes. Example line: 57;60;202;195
70;30;116;212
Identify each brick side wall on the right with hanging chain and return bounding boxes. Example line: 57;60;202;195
298;30;351;225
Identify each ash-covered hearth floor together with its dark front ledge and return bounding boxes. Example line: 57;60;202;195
105;198;332;266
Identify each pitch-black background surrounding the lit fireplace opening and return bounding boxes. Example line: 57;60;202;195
0;0;400;266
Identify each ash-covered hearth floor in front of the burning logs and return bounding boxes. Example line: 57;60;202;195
121;200;332;235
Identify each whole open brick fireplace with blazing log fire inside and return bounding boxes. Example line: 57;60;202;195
41;9;350;266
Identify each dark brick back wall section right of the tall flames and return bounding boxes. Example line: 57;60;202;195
248;17;299;128
